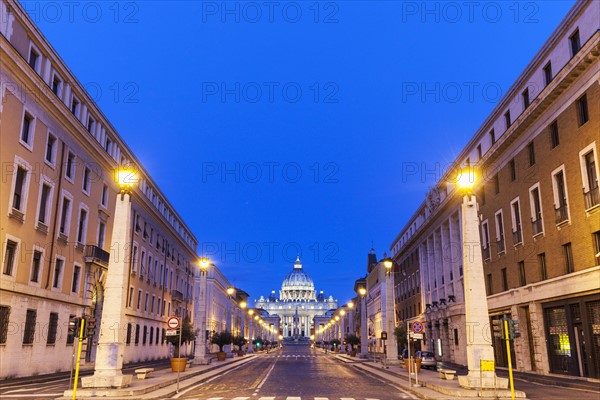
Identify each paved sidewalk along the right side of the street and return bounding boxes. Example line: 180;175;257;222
333;354;526;400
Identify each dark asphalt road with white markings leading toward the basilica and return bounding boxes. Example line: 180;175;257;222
173;344;417;400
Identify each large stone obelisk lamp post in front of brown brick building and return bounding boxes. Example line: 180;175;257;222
457;168;508;388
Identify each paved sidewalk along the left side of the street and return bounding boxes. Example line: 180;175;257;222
57;353;257;400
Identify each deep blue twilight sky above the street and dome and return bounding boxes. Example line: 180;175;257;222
21;0;574;303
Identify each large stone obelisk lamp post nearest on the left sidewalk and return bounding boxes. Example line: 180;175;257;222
81;168;137;388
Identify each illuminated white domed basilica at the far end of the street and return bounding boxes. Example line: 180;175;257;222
254;257;338;339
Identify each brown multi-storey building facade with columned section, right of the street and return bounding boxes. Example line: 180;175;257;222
391;1;600;378
